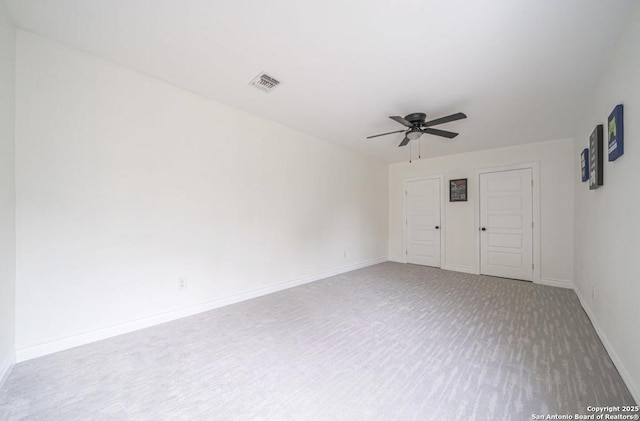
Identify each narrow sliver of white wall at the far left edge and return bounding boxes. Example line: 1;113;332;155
0;2;16;385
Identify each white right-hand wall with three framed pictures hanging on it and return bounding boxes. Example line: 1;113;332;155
573;6;640;403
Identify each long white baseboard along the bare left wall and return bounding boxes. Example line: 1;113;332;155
16;256;387;362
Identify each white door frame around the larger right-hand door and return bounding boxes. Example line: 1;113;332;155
473;162;540;284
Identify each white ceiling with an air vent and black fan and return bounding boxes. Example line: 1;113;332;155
6;0;635;162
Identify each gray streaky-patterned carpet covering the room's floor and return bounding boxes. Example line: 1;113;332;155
0;263;634;420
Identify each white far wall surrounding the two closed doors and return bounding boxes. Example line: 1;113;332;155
389;139;575;286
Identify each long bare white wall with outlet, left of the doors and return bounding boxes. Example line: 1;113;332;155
16;31;388;359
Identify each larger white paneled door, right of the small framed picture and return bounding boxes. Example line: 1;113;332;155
480;168;533;281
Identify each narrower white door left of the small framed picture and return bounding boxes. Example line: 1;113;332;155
405;179;440;267
